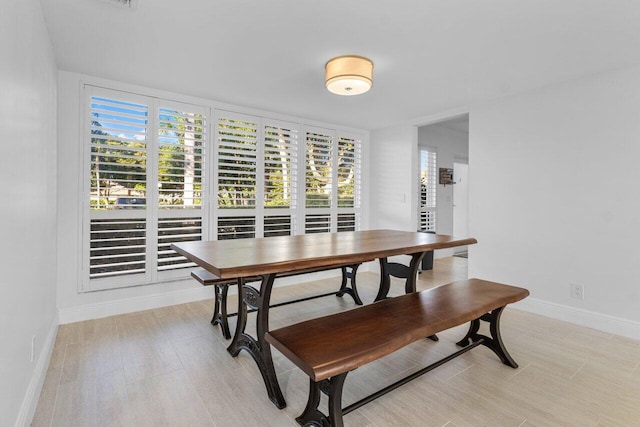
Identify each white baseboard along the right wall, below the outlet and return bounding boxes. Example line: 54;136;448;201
513;297;640;340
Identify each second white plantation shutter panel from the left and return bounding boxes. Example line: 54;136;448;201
157;106;206;271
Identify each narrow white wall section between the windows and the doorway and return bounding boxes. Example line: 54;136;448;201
369;126;419;231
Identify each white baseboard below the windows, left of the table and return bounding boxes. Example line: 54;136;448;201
58;286;213;325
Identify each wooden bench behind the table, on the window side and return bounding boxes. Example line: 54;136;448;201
191;264;362;339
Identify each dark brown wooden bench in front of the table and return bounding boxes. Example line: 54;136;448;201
266;279;529;426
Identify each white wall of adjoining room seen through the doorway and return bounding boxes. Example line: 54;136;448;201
418;124;469;258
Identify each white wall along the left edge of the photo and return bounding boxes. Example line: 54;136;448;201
0;0;57;426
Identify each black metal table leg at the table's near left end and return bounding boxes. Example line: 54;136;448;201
227;274;287;409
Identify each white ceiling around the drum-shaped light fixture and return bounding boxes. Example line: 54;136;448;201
41;0;640;129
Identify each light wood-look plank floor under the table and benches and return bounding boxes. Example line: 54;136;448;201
33;258;640;427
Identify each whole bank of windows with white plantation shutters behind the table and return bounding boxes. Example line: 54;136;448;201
82;90;362;291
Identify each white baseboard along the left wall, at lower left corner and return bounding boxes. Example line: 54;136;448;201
16;318;58;427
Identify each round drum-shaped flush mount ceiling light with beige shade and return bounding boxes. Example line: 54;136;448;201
324;55;373;95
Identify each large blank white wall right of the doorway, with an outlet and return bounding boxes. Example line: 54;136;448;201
469;63;640;338
